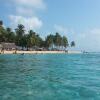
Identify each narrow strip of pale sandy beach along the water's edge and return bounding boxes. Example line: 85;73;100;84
0;50;82;54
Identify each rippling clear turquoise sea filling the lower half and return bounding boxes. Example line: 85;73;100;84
0;54;100;100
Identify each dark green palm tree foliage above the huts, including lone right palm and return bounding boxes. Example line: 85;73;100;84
0;21;75;49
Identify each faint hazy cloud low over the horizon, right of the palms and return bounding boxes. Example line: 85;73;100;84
54;25;100;51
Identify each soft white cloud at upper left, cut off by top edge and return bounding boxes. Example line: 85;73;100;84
10;0;46;16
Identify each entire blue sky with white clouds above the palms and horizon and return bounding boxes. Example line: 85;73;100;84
0;0;100;52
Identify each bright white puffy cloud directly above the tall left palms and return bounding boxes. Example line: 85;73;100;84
9;15;43;30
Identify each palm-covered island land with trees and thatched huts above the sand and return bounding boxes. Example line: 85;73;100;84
0;21;79;53
